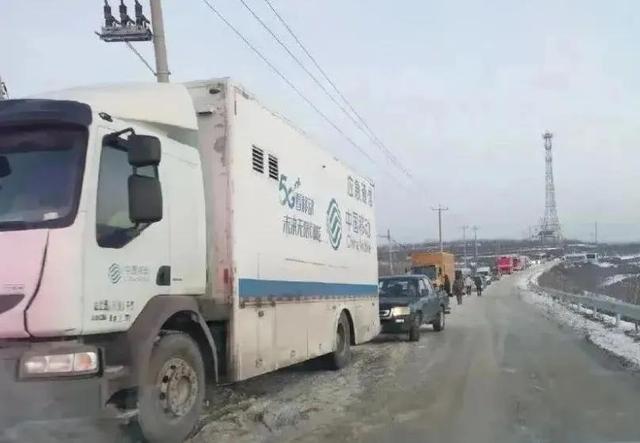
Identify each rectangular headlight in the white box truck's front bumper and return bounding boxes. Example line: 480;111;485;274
20;349;99;377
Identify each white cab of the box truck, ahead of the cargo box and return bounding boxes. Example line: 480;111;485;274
0;85;214;442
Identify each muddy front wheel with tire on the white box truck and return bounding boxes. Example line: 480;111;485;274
138;332;205;443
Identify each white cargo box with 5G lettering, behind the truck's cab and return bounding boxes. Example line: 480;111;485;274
187;80;379;380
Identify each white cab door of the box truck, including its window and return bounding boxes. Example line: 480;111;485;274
83;130;170;333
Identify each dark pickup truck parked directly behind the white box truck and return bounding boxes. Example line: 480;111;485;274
378;275;449;341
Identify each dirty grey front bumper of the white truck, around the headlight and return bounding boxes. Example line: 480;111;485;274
0;342;130;441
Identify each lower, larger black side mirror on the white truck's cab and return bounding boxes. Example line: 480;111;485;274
127;174;162;224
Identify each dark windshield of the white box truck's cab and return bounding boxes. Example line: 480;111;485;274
0;126;87;230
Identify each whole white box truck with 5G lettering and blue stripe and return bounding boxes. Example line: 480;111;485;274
0;79;380;442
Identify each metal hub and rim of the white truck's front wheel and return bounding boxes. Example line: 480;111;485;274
157;358;198;417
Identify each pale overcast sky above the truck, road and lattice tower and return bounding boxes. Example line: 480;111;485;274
0;0;640;241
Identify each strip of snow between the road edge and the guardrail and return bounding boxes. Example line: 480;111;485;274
518;266;640;369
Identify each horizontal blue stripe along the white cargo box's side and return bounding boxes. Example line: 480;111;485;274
238;278;378;298
